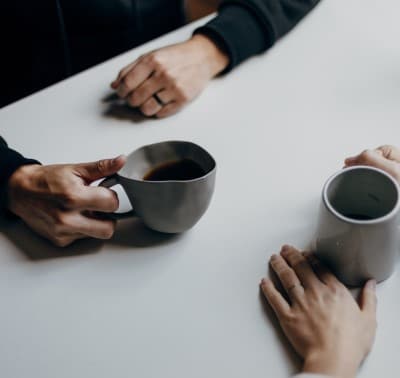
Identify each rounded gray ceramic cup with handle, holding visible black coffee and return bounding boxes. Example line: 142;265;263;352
100;141;216;233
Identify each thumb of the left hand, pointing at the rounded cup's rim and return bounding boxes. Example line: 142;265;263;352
75;155;126;182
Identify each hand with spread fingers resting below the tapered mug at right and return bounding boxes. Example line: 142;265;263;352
261;246;376;378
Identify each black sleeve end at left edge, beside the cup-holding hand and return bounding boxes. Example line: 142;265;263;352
0;136;40;214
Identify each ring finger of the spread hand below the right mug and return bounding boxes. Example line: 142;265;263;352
270;255;304;300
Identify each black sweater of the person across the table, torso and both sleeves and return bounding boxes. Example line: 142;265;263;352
0;0;319;208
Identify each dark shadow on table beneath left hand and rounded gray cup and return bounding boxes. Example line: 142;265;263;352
0;218;180;261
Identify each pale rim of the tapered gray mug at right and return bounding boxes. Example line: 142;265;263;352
322;165;400;225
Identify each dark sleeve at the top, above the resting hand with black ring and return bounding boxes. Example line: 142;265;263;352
195;0;319;72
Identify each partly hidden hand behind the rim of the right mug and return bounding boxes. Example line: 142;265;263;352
344;145;400;183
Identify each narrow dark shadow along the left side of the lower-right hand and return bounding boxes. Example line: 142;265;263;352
259;269;302;374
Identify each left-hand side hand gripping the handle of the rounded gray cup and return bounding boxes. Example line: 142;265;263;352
8;156;126;247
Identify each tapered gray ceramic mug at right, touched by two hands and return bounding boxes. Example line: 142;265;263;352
315;166;400;286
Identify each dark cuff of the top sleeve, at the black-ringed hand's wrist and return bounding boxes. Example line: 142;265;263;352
194;4;274;73
